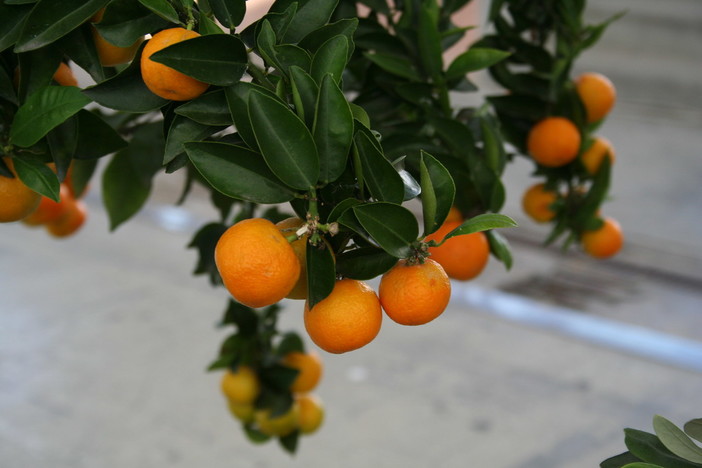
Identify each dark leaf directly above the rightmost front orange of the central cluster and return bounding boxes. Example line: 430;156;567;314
352;202;419;258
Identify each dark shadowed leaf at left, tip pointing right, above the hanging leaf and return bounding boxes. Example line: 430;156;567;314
74;109;127;159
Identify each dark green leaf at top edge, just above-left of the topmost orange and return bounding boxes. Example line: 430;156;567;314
94;0;169;47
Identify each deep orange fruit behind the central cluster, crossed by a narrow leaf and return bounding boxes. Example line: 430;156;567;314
424;221;490;281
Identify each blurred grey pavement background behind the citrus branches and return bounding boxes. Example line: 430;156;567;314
0;0;702;468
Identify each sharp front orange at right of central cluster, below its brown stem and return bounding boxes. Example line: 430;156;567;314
378;258;451;325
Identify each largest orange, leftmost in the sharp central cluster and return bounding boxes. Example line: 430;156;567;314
215;218;300;307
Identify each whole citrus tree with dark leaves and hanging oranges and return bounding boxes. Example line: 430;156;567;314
0;0;623;451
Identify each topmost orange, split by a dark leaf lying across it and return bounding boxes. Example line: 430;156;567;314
141;28;209;101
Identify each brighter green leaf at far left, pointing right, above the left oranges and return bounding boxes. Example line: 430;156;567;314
10;86;90;148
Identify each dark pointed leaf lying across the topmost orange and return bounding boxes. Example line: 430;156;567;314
151;34;248;86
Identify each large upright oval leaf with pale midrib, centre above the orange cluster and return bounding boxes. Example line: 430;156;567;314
248;92;319;190
